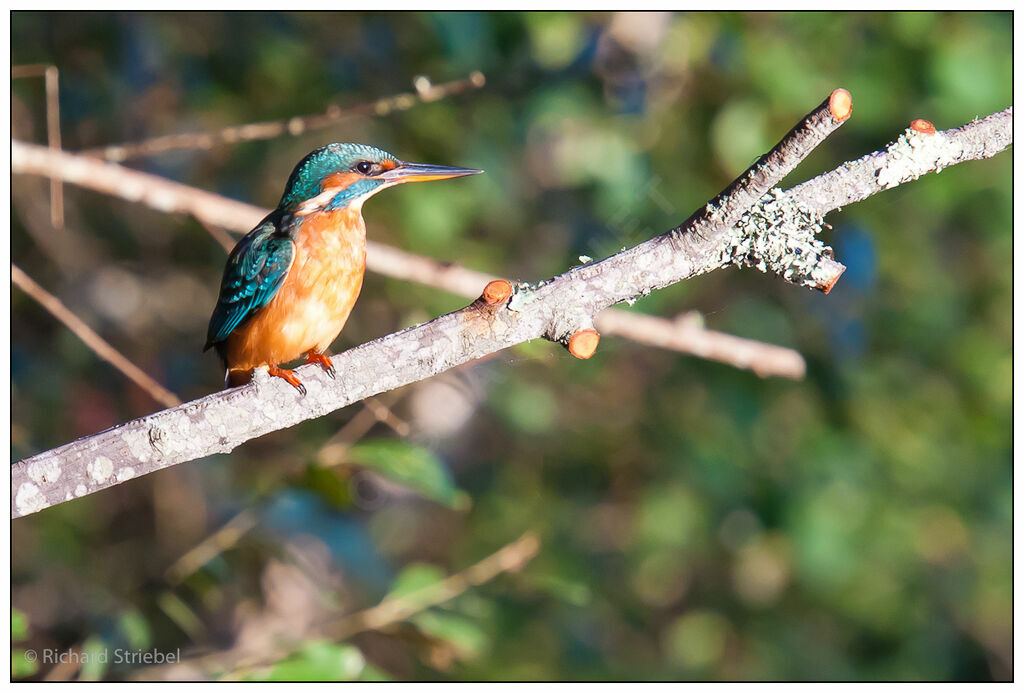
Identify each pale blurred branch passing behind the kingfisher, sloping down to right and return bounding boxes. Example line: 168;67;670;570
11;140;805;379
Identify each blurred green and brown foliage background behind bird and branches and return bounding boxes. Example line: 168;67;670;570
11;12;1013;681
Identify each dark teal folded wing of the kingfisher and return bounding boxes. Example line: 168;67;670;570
203;214;295;351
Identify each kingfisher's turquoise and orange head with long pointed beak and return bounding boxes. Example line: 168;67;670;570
279;142;483;213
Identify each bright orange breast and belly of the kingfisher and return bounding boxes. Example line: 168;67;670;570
226;209;367;371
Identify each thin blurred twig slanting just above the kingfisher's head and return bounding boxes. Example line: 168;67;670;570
82;72;486;162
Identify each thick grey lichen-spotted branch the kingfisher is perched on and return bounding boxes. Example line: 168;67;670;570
11;91;1012;517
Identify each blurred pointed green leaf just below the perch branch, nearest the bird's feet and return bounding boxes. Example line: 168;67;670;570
348;439;469;509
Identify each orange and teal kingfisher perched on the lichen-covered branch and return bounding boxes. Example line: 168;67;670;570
203;142;483;394
